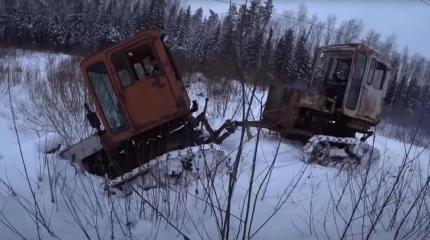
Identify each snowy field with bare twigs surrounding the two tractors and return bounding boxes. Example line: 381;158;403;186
0;53;430;239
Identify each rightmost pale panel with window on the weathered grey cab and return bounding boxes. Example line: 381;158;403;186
358;57;387;122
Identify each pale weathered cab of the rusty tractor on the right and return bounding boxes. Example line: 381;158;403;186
309;44;389;122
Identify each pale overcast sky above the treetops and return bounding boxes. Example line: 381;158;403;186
184;0;430;58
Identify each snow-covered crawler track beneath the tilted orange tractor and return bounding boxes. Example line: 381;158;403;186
106;144;227;192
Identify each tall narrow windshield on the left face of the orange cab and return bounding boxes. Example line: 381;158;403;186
87;62;128;133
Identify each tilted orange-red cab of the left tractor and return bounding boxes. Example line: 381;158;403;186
81;29;190;148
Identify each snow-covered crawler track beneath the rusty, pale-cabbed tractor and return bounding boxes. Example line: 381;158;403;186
303;135;379;169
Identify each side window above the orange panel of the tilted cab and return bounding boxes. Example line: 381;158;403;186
112;44;160;87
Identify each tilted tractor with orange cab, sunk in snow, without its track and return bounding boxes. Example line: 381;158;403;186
60;30;234;184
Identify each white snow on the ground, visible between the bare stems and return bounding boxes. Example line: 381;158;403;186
0;53;430;239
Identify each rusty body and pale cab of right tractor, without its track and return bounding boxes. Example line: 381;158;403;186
263;44;390;140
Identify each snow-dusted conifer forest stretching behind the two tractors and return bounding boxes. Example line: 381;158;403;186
0;0;430;123
